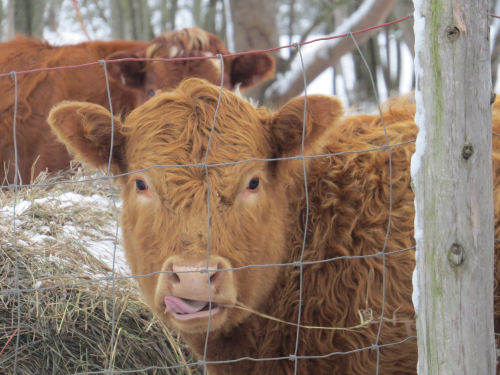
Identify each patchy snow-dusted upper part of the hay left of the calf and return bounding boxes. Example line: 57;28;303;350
0;172;130;284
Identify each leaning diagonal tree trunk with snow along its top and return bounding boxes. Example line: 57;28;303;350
265;0;396;105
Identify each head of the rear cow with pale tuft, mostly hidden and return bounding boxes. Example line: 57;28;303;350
107;27;274;104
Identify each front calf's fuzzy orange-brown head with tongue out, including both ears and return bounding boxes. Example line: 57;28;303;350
49;79;342;333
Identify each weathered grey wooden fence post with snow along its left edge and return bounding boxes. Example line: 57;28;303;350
411;0;496;375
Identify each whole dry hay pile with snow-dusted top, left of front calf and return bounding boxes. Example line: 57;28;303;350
0;169;198;375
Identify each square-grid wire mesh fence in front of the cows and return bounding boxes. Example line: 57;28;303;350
0;11;498;375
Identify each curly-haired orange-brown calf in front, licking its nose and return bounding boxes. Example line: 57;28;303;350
49;79;500;375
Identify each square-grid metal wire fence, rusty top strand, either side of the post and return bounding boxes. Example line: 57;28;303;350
0;14;500;375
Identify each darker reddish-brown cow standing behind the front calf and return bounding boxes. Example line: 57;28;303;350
0;28;274;185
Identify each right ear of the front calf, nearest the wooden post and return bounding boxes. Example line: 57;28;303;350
270;95;344;157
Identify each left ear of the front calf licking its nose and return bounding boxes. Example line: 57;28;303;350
47;102;125;174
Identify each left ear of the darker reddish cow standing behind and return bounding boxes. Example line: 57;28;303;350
106;51;146;89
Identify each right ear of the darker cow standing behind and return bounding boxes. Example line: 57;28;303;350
231;53;274;89
